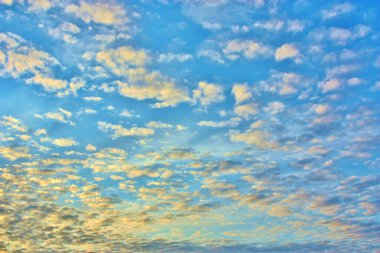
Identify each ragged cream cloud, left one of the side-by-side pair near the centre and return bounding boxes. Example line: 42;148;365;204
193;81;224;106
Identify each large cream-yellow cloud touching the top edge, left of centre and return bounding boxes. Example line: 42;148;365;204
65;0;128;25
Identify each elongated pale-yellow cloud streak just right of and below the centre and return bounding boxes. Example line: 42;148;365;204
230;130;279;149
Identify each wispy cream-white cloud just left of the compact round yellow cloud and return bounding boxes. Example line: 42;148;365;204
223;39;271;60
